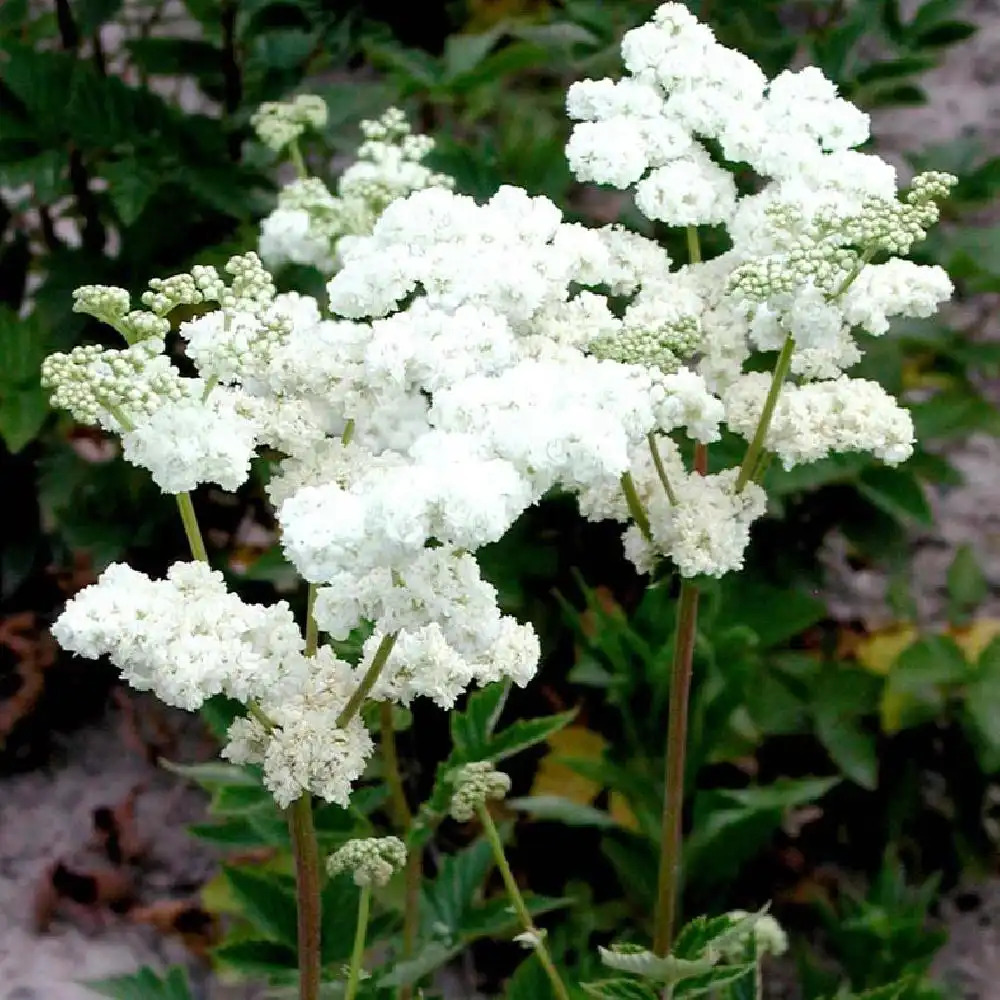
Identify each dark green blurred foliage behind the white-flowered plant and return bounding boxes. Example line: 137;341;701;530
0;0;1000;998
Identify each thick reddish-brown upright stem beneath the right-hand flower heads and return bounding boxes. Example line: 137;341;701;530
653;580;698;955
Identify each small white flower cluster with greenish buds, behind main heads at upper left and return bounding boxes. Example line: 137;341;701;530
259;108;454;274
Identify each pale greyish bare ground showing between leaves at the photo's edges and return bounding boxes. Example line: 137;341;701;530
0;0;1000;1000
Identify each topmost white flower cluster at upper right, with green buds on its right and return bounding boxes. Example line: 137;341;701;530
566;3;954;388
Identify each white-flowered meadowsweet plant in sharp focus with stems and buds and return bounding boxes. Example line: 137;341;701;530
44;3;953;1000
